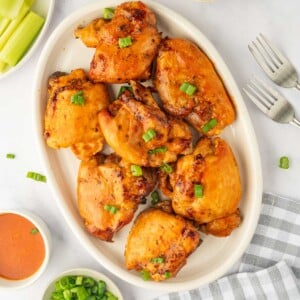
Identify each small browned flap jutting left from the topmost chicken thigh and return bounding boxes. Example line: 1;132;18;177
74;18;107;48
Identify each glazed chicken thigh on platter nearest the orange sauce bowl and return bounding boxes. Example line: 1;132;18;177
77;154;156;242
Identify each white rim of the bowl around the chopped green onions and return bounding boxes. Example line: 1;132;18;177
42;268;124;300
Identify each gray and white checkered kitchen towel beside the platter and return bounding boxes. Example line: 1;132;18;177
154;193;300;300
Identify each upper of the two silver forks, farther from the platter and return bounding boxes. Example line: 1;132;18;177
248;33;300;90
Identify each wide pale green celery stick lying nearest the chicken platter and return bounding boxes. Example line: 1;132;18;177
0;11;45;66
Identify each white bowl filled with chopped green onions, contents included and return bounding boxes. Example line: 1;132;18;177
42;268;124;300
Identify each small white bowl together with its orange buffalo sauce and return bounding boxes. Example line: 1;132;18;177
0;211;50;288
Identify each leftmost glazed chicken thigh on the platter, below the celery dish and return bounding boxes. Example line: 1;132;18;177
44;69;109;160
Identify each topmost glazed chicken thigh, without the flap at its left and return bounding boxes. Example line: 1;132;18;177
89;1;161;83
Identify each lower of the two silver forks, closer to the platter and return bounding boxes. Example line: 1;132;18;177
243;77;300;128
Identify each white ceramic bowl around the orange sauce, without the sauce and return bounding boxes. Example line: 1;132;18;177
0;209;51;290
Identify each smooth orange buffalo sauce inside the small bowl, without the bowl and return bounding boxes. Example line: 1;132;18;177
0;213;45;280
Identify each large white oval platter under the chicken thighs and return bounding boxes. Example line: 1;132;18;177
34;0;262;292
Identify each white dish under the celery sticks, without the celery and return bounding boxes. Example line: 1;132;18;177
0;0;55;80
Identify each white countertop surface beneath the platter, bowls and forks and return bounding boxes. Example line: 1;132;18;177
0;0;300;300
